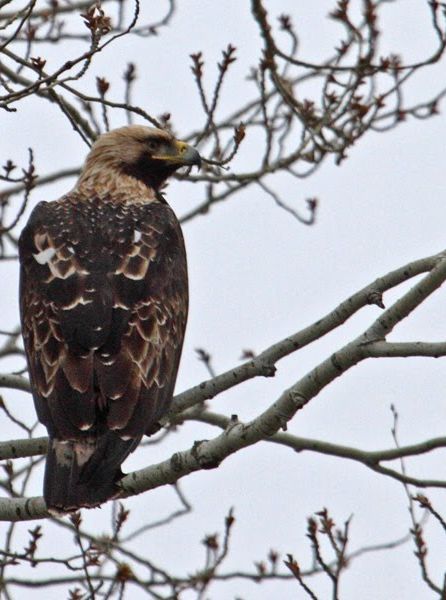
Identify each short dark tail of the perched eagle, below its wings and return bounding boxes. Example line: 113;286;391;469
43;431;140;513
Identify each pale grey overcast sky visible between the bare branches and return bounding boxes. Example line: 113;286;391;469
0;0;446;600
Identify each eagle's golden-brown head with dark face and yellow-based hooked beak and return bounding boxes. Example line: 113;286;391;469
81;125;201;190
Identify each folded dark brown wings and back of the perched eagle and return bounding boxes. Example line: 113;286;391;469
19;196;187;439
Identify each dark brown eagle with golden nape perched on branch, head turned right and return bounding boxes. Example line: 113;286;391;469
19;125;201;514
